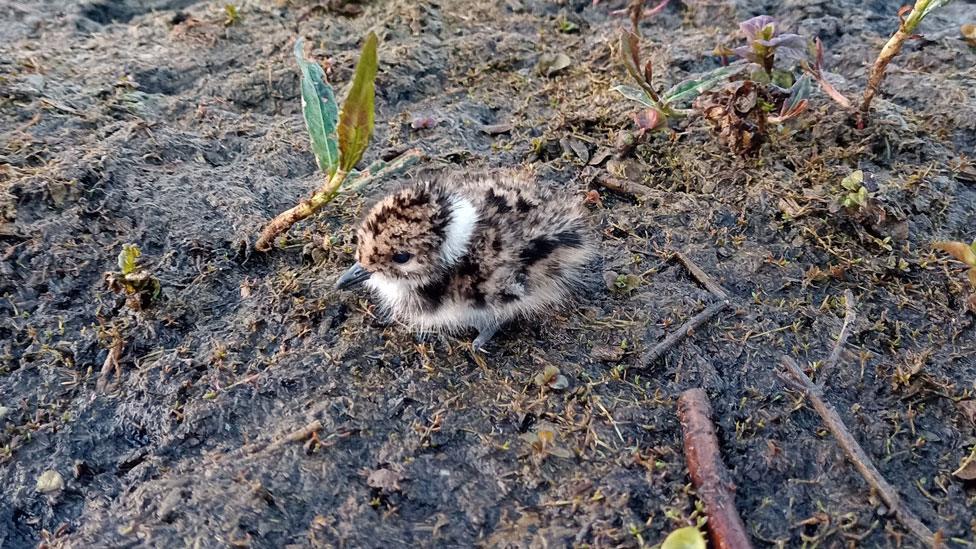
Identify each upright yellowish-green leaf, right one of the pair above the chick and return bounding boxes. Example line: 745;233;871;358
339;31;379;172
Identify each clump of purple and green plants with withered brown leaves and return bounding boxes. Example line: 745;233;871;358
613;15;811;154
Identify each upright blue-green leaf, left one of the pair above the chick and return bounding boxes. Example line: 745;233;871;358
295;38;339;176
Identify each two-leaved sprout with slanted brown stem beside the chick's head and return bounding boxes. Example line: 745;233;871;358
254;32;378;252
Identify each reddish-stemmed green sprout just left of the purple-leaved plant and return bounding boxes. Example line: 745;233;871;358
612;31;742;131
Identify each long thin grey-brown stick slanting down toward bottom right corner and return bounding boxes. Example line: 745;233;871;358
780;356;936;547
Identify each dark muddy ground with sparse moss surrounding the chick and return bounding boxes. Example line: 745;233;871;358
0;0;976;548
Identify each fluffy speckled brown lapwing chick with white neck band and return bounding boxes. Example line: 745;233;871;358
336;174;595;350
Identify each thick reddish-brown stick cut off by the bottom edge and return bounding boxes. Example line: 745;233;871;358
678;389;752;549
